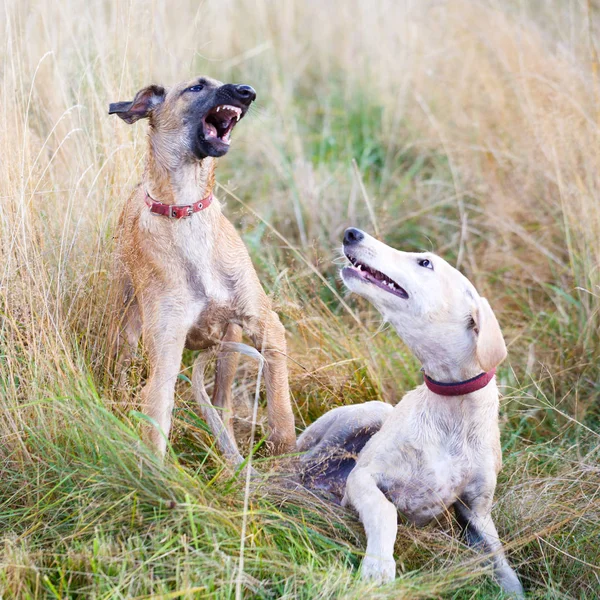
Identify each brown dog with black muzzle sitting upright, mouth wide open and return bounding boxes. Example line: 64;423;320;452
109;77;296;463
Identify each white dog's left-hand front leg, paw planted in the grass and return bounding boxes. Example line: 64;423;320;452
342;469;398;583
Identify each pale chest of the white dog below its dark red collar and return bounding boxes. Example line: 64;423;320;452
366;388;494;525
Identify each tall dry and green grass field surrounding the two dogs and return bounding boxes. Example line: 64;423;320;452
0;0;600;599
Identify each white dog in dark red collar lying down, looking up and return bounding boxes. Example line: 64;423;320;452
298;229;523;597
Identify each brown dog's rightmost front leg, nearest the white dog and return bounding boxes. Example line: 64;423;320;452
255;311;296;454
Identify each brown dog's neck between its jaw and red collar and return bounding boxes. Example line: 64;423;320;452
143;140;216;204
